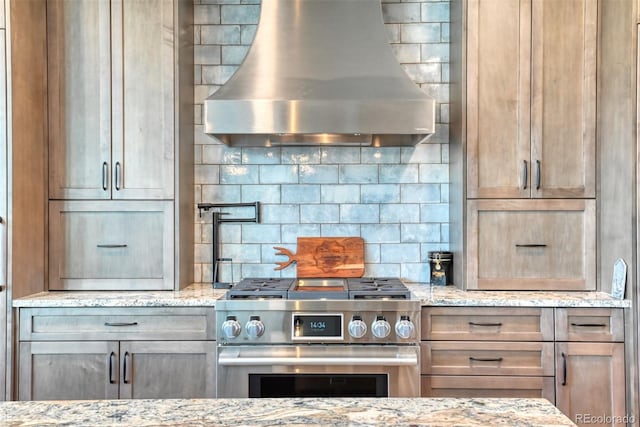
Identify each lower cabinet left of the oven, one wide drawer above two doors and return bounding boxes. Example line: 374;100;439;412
17;307;216;400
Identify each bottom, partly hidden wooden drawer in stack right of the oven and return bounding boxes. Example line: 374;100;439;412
421;375;555;403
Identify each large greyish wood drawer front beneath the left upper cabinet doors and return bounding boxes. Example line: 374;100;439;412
49;201;174;290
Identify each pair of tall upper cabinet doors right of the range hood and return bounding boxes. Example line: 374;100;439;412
466;0;598;198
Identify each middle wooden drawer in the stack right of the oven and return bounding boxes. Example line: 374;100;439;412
421;341;554;376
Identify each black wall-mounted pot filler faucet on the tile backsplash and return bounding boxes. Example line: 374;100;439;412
198;202;260;289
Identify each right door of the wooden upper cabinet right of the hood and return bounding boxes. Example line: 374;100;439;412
531;0;598;198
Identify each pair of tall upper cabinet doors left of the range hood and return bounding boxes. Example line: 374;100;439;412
47;0;175;199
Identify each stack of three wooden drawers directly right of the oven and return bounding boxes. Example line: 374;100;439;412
421;307;555;402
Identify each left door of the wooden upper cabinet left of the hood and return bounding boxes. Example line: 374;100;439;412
47;0;111;199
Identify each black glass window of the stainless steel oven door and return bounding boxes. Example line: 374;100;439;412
249;374;389;398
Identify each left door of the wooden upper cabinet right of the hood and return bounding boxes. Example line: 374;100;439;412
467;0;531;198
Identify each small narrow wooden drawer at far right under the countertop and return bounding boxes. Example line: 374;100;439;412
556;308;624;342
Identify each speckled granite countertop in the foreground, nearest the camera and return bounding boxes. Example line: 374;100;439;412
0;398;575;427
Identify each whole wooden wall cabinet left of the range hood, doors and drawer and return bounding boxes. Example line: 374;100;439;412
47;0;193;290
